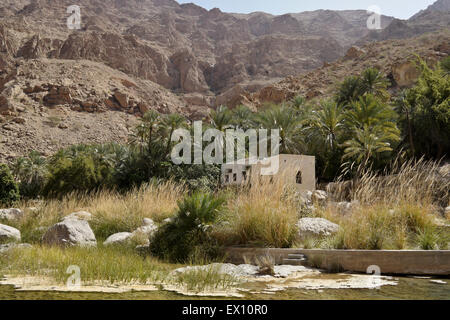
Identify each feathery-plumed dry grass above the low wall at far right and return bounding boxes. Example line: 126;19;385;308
317;159;450;250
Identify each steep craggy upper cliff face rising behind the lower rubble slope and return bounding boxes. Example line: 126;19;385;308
0;0;390;102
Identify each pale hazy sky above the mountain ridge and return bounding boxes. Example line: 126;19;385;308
177;0;436;19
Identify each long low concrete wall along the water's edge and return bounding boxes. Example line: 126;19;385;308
227;248;450;275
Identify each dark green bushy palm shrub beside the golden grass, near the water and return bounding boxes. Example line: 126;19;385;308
150;193;225;262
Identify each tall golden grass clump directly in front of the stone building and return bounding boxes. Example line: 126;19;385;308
218;172;298;248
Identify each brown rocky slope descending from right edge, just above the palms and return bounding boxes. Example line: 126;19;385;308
243;29;450;109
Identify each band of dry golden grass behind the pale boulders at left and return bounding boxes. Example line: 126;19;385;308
10;181;187;243
